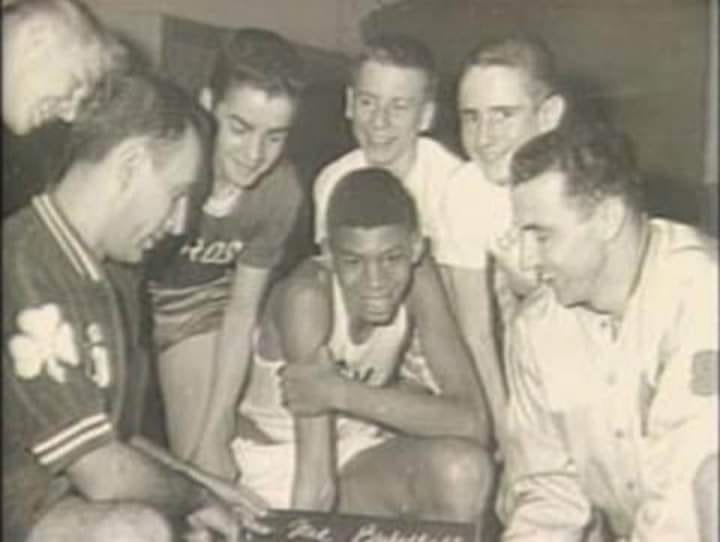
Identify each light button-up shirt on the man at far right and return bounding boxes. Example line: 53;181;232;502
500;219;718;542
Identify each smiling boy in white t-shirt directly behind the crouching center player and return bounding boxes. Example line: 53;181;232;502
314;34;461;244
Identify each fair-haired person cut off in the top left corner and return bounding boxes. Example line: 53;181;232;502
2;0;129;216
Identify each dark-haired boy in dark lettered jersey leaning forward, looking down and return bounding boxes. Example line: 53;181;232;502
150;28;305;478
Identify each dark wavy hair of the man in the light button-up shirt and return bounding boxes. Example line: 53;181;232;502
510;120;644;212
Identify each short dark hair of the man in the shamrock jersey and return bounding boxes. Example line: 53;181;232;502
67;74;209;168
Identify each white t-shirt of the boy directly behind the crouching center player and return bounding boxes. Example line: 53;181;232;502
314;137;462;243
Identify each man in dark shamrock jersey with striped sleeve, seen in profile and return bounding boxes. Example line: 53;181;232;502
2;72;266;542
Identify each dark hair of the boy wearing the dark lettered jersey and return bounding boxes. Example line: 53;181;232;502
209;28;306;104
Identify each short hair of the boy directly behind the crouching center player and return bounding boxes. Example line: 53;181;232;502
351;34;438;98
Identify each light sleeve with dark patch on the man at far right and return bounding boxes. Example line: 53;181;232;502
631;254;718;542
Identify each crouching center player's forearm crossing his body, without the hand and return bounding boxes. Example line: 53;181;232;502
332;379;487;442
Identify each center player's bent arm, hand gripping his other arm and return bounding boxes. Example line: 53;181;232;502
283;262;489;443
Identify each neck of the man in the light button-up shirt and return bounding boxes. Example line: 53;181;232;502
592;216;650;319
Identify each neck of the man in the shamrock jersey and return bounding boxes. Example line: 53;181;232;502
52;165;107;259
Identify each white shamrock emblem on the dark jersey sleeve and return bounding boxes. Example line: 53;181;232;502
8;304;80;383
